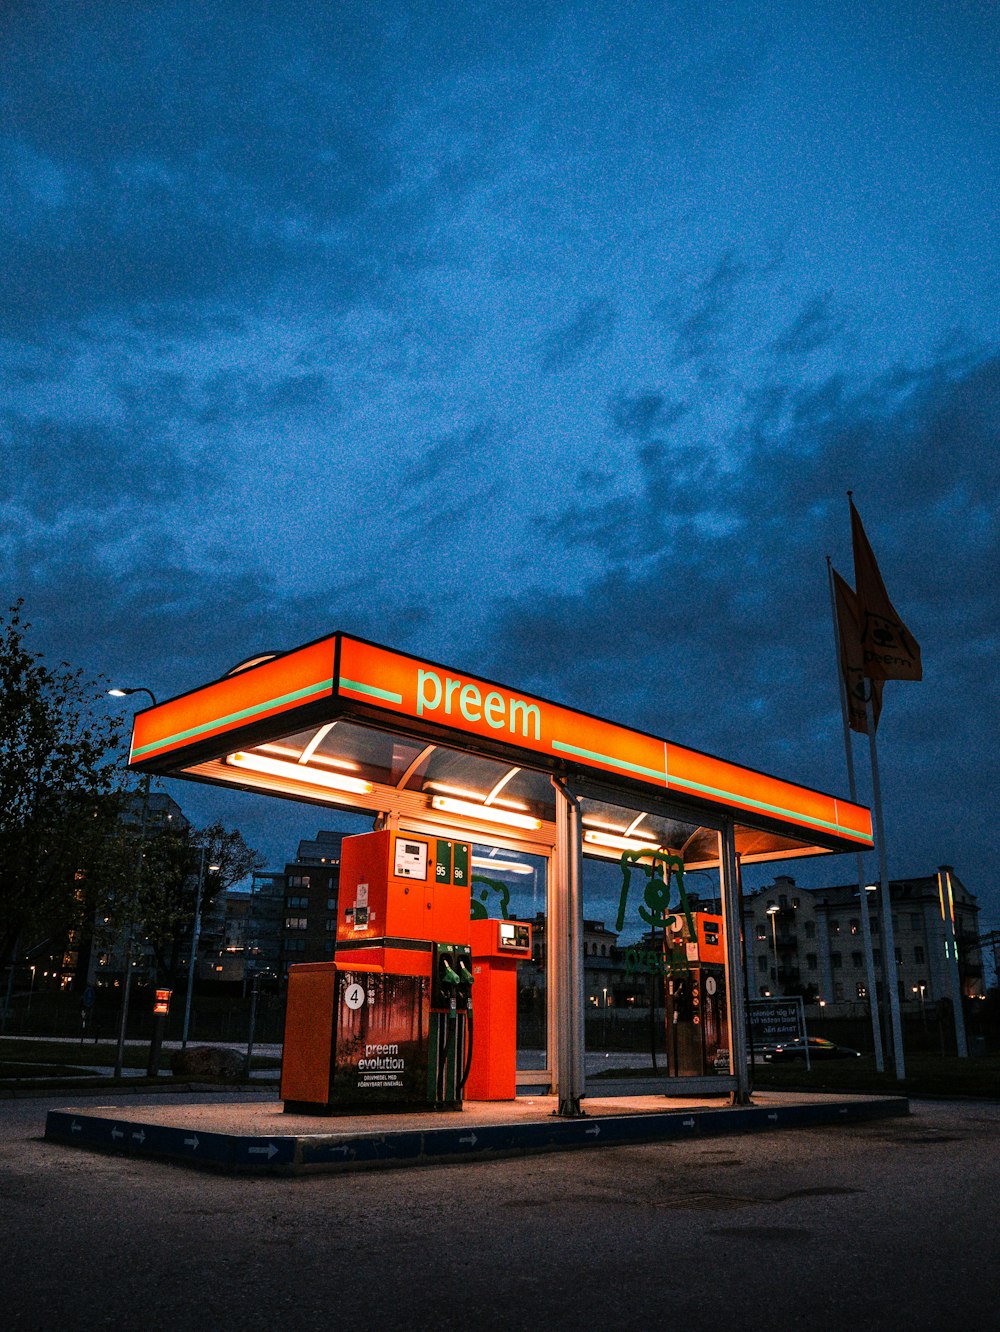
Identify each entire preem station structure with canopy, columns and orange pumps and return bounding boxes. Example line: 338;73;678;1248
129;633;872;1116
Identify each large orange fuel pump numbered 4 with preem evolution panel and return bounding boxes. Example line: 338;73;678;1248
281;829;473;1114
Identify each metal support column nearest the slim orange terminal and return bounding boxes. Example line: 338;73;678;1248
549;779;585;1119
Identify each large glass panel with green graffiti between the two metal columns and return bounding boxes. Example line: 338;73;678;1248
582;799;730;1095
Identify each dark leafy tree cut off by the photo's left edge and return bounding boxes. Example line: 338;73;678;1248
0;601;124;966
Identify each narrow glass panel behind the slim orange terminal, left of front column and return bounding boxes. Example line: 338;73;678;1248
471;842;549;1070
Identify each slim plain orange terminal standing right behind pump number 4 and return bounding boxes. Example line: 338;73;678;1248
465;920;531;1100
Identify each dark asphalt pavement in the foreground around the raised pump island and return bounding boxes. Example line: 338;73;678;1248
0;1096;1000;1332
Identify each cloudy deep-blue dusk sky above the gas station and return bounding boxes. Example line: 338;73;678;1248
0;0;1000;926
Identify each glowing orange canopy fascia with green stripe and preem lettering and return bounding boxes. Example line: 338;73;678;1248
130;633;872;850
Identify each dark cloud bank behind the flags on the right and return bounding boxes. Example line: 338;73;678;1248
486;357;1000;863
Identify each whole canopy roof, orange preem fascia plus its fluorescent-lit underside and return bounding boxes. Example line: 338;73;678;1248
129;633;872;868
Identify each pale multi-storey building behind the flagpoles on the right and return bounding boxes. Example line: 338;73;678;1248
743;866;985;1018
